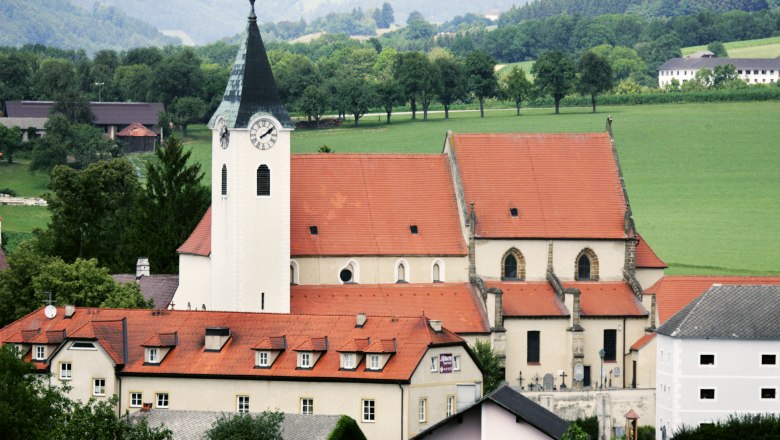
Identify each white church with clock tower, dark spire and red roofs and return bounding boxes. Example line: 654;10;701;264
173;0;666;396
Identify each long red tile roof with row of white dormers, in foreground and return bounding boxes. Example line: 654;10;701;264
0;308;465;381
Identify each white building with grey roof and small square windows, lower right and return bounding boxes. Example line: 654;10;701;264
656;285;780;440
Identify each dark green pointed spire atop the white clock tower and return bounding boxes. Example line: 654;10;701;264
209;0;293;128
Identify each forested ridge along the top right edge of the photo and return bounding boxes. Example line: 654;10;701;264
501;0;780;24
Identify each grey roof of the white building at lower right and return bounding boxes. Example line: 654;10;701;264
656;284;780;340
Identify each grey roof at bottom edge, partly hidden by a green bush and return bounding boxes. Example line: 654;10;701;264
131;409;341;440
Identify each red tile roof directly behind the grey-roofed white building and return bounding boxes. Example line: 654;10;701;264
645;276;780;325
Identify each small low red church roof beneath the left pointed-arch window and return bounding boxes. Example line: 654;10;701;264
486;281;569;317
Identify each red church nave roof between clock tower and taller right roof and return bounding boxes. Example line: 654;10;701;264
290;154;468;256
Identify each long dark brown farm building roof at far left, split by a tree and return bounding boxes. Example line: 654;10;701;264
5;101;165;126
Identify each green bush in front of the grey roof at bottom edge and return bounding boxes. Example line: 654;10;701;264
206;411;284;440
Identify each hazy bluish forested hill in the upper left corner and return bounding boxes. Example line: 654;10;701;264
0;0;179;53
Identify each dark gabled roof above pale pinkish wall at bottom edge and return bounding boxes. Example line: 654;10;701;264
412;385;569;440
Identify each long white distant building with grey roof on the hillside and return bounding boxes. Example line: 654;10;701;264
658;52;780;88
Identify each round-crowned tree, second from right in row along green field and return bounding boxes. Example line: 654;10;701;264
531;51;576;115
